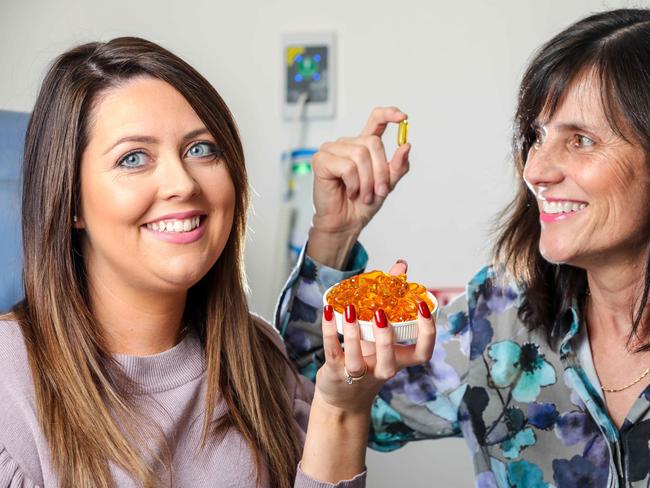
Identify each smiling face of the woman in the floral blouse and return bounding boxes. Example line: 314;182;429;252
524;73;650;269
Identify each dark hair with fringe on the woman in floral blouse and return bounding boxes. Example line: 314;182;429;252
494;9;650;351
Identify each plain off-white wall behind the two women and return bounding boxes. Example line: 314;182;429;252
0;0;636;488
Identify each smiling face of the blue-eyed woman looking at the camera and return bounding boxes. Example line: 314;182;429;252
76;78;235;293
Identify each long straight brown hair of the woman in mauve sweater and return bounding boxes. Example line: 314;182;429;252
14;37;301;488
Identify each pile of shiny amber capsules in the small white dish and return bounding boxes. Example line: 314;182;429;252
327;271;433;322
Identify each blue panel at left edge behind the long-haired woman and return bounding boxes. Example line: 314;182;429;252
0;110;29;312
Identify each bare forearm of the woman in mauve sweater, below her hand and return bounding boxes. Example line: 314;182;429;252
300;391;370;483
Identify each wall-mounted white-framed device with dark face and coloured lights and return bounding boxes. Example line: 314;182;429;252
282;32;336;120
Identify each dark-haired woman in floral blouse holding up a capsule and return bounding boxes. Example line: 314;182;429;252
278;10;650;488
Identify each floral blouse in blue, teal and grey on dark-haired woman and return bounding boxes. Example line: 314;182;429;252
275;244;650;488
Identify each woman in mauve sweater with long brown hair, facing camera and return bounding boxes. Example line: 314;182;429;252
0;38;433;488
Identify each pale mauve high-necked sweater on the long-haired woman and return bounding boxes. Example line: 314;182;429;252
0;322;365;488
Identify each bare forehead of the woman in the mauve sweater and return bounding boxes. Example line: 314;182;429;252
89;77;203;143
